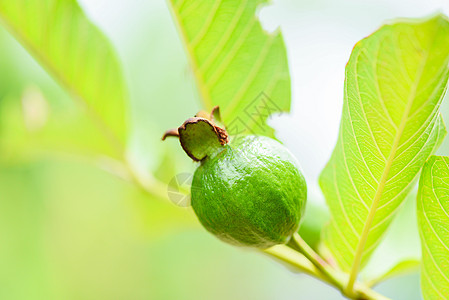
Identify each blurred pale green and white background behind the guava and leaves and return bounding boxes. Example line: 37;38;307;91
0;0;449;300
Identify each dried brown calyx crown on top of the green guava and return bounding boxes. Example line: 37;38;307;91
162;106;229;161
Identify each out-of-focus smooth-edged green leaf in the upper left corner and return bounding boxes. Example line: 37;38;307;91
0;0;127;152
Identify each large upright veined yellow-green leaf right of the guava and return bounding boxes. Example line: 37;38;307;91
320;15;449;274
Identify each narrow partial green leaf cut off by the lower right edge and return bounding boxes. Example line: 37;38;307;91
418;156;449;299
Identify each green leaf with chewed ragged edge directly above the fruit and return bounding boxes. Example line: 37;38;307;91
170;0;291;136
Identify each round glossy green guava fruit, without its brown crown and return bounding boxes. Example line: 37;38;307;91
191;136;307;249
